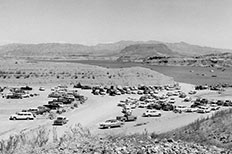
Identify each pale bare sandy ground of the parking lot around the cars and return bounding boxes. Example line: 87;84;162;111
0;83;232;139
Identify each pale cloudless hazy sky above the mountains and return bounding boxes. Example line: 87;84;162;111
0;0;232;49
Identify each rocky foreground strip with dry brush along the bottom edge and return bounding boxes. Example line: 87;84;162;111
0;126;229;154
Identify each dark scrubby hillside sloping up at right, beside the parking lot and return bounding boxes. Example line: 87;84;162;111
160;109;232;150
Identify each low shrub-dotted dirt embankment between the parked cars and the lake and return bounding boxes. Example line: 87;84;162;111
0;60;174;86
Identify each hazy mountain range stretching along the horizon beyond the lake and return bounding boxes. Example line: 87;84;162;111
0;41;232;59
